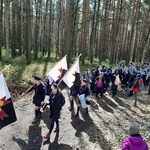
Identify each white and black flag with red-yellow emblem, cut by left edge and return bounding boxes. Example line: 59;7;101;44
0;72;17;129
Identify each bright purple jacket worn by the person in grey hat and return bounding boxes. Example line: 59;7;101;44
122;134;148;150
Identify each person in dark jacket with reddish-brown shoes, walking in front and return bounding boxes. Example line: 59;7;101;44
44;83;62;139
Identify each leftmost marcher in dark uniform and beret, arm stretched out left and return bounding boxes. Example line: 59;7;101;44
22;75;45;123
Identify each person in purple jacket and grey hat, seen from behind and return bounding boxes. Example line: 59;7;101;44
122;125;148;150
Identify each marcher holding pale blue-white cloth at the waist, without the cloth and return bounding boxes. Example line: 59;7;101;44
76;79;90;116
